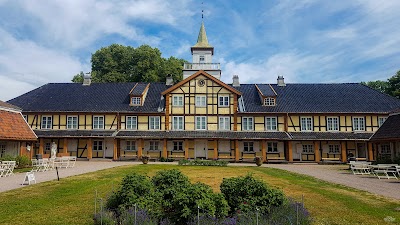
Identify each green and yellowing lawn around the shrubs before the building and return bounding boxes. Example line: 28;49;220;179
0;164;400;225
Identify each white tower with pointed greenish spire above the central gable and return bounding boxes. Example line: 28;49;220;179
183;22;221;79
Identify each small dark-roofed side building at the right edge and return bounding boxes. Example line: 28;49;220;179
370;109;400;162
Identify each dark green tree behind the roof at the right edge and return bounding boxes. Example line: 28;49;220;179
361;70;400;98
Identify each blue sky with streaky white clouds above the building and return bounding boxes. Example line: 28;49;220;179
0;0;400;100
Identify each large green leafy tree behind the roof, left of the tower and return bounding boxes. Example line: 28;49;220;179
72;44;186;83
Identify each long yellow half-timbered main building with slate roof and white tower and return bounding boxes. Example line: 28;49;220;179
9;23;400;162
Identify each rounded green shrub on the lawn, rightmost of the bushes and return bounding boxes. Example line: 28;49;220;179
220;174;285;215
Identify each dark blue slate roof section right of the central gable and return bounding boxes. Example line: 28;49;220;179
235;83;400;113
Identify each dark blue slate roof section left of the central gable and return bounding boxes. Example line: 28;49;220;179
8;83;167;113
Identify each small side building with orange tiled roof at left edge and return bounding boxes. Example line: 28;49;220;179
0;101;37;158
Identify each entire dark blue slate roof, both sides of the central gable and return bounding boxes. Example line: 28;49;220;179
8;83;400;113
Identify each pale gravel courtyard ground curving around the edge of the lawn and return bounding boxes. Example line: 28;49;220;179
0;161;400;200
